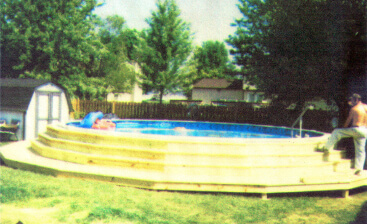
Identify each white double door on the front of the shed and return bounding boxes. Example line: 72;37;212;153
35;92;61;137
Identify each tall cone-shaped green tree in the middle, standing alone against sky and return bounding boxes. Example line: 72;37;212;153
138;0;192;103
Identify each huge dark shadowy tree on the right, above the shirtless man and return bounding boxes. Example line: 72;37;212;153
227;0;366;111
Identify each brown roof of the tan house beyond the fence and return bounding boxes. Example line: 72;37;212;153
194;79;243;89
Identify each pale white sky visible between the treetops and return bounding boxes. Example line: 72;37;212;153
95;0;242;45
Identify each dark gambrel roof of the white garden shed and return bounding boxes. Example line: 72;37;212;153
0;79;72;111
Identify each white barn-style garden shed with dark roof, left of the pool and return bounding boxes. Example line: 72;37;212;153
0;79;72;140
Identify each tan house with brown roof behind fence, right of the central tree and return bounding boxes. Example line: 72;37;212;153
192;79;264;104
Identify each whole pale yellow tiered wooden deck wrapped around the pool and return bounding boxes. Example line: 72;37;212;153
0;126;367;199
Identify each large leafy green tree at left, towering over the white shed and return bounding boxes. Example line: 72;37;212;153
0;0;104;98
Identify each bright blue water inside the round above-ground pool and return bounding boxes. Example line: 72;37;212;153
69;120;323;138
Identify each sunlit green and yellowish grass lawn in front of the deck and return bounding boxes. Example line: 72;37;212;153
0;166;367;224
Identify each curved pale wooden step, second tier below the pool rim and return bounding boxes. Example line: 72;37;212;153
39;134;344;166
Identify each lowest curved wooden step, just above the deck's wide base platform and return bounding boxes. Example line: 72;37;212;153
31;141;350;178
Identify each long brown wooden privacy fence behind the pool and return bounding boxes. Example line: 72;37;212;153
72;99;333;132
